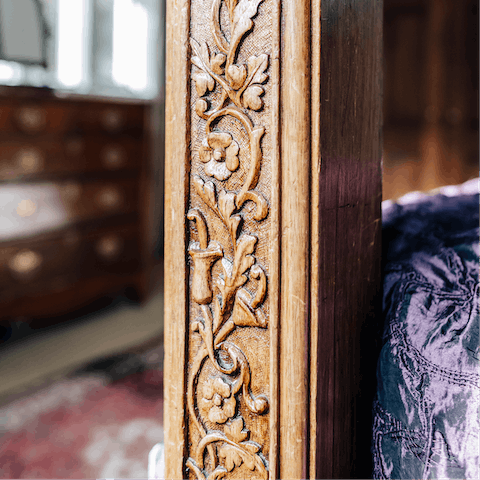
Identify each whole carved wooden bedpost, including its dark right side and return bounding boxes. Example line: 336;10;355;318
165;0;382;480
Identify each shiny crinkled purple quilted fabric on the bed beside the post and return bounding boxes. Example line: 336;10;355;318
372;183;480;479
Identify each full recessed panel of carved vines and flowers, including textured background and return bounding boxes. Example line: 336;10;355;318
186;0;272;480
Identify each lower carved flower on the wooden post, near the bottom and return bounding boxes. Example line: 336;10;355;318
201;377;237;423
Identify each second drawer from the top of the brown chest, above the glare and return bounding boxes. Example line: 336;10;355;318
0;135;143;180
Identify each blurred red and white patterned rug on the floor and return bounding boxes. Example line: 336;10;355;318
0;369;163;478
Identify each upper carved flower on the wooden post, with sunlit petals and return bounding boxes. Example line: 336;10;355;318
199;132;240;180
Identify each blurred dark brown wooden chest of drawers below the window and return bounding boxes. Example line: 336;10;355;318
0;89;149;322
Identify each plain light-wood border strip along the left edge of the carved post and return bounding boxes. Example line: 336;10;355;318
164;0;190;479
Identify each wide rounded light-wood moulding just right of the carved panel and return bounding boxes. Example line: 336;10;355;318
279;0;311;479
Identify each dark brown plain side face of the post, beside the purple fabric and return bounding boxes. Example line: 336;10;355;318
312;0;382;478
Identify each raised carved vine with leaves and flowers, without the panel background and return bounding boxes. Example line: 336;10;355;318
186;0;269;480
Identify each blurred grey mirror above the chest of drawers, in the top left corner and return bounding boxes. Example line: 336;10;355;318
0;0;50;67
